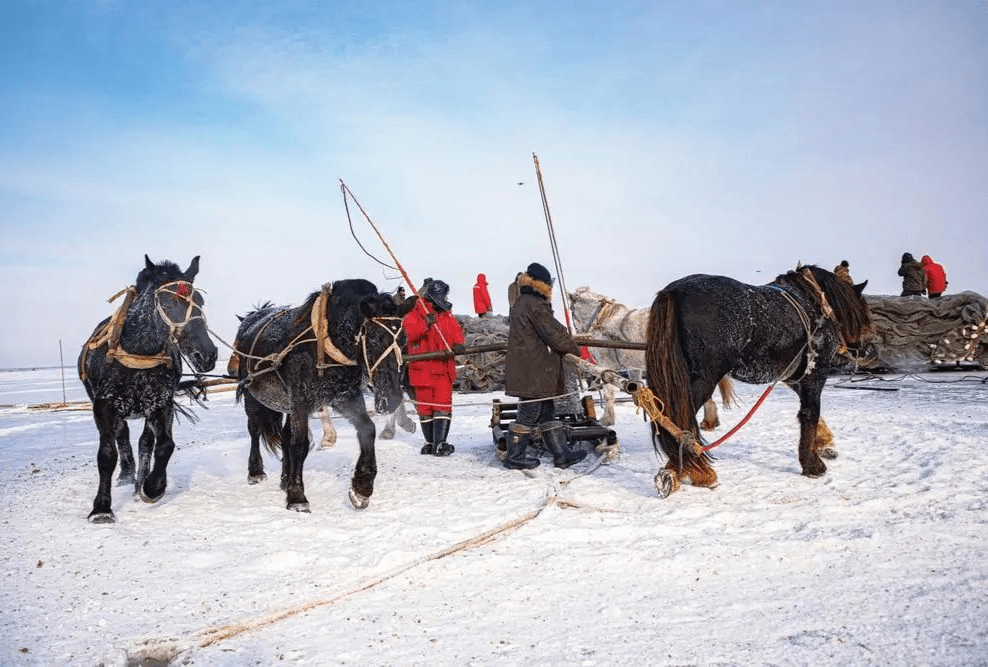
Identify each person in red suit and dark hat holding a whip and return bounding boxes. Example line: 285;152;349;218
403;278;464;456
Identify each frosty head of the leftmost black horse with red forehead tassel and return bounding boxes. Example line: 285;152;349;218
141;255;218;373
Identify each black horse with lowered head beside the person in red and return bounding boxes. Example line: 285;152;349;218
231;279;416;512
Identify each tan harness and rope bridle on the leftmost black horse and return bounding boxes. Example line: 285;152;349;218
79;280;206;381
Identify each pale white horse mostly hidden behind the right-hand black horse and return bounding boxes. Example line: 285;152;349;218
569;287;734;431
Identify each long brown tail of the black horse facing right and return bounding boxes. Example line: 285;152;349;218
645;290;707;474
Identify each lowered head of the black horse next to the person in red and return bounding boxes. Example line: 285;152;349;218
359;293;418;414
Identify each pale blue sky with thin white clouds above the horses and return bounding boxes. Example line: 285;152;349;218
0;0;988;368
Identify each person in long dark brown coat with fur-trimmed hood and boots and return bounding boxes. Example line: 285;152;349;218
504;263;587;470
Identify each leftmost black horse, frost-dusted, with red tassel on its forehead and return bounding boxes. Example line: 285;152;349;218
78;255;216;523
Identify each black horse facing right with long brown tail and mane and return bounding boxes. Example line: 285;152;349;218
645;266;871;497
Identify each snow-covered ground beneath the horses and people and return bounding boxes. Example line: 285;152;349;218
0;369;988;665
